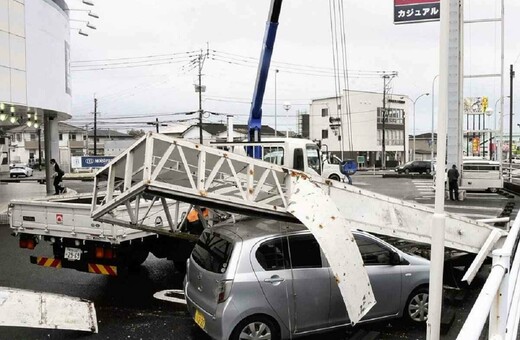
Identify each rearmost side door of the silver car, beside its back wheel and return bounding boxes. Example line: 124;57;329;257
251;236;294;331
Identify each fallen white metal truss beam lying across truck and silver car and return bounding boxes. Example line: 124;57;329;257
92;133;505;253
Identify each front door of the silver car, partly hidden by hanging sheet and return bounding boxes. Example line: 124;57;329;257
330;234;402;325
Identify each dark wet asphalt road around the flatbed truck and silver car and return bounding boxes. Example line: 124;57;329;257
0;177;516;340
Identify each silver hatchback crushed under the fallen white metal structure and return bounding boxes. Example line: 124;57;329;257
184;219;429;340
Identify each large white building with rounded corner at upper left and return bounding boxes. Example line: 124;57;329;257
0;0;71;171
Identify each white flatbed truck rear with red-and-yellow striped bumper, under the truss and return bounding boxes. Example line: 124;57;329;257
9;194;198;276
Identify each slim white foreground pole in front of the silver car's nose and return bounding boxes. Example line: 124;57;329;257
426;0;450;340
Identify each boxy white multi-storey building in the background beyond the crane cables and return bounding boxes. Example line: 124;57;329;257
302;91;412;167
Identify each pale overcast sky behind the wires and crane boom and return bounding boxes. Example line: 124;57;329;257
68;0;520;133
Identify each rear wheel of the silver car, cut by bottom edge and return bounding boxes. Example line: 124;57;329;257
229;315;280;340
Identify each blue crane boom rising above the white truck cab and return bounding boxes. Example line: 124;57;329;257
248;0;282;158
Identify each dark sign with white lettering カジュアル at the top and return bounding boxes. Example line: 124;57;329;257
394;0;441;24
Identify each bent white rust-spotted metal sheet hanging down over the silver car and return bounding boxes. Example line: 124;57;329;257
288;174;376;323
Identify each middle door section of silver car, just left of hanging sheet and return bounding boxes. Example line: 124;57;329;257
288;234;330;333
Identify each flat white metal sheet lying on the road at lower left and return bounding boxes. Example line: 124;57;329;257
0;287;98;333
